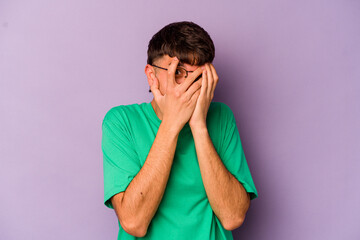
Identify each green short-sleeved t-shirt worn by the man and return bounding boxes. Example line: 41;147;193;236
102;102;258;240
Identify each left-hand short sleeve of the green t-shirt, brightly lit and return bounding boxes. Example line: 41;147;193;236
101;106;141;208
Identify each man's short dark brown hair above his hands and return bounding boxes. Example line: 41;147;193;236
147;21;215;66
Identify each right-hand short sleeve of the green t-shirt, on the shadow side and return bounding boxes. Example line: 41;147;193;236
219;103;258;200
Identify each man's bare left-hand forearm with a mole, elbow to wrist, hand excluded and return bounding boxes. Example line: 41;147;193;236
111;121;180;237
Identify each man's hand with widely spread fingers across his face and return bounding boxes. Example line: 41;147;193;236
151;57;203;131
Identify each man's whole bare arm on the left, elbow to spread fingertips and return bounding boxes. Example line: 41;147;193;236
112;57;201;237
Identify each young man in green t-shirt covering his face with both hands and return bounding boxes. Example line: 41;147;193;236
102;22;257;240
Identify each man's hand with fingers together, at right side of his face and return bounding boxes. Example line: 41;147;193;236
189;63;219;128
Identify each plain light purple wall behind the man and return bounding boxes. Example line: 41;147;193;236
0;0;360;240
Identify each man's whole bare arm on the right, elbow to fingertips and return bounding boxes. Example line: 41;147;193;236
189;63;250;230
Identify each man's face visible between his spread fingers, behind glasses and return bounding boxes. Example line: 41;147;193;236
149;55;199;95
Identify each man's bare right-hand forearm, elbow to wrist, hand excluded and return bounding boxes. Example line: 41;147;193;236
191;126;250;230
